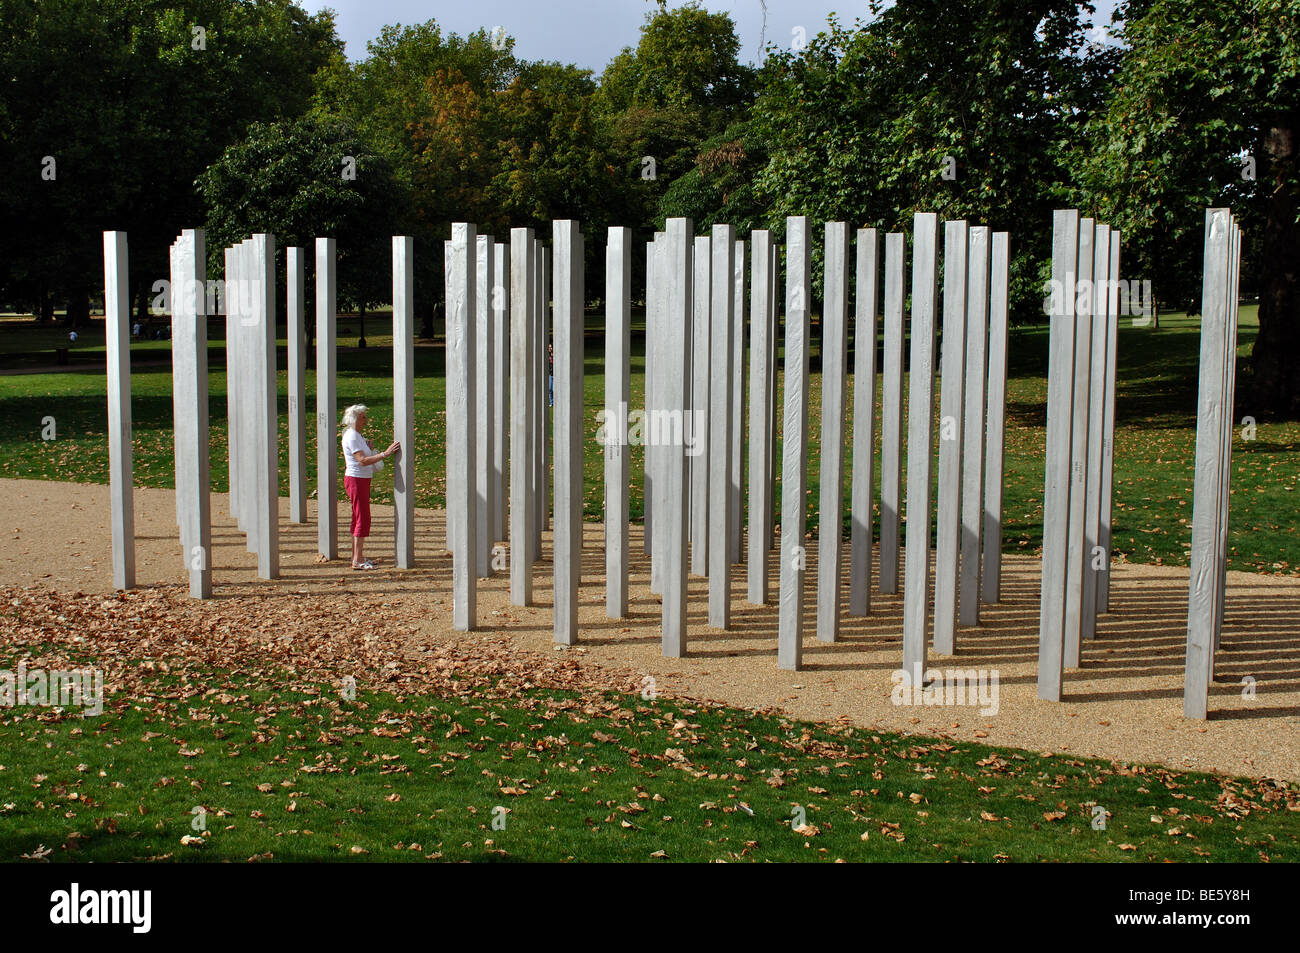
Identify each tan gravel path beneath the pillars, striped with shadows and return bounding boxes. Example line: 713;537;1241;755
0;480;1300;781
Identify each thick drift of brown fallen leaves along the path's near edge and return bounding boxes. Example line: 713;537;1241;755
0;586;640;707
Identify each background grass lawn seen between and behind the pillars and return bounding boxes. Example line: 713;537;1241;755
0;307;1300;572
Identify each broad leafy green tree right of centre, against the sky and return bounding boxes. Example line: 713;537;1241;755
754;0;1110;321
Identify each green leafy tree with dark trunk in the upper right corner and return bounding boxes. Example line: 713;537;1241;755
1086;0;1300;416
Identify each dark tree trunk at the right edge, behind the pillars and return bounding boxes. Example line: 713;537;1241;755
1251;124;1300;417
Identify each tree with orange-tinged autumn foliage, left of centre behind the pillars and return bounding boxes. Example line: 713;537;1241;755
315;21;629;308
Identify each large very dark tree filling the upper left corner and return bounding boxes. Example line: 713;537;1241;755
0;0;341;321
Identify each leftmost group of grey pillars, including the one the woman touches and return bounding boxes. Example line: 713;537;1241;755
104;229;415;598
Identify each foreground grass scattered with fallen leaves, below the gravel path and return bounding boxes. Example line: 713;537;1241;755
0;659;1300;862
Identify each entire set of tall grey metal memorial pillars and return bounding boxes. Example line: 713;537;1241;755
104;209;1258;718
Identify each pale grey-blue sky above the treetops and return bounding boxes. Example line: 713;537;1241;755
299;0;1117;73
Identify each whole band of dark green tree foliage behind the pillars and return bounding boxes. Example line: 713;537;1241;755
0;0;1300;415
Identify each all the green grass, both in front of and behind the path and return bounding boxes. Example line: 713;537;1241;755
0;308;1300;861
